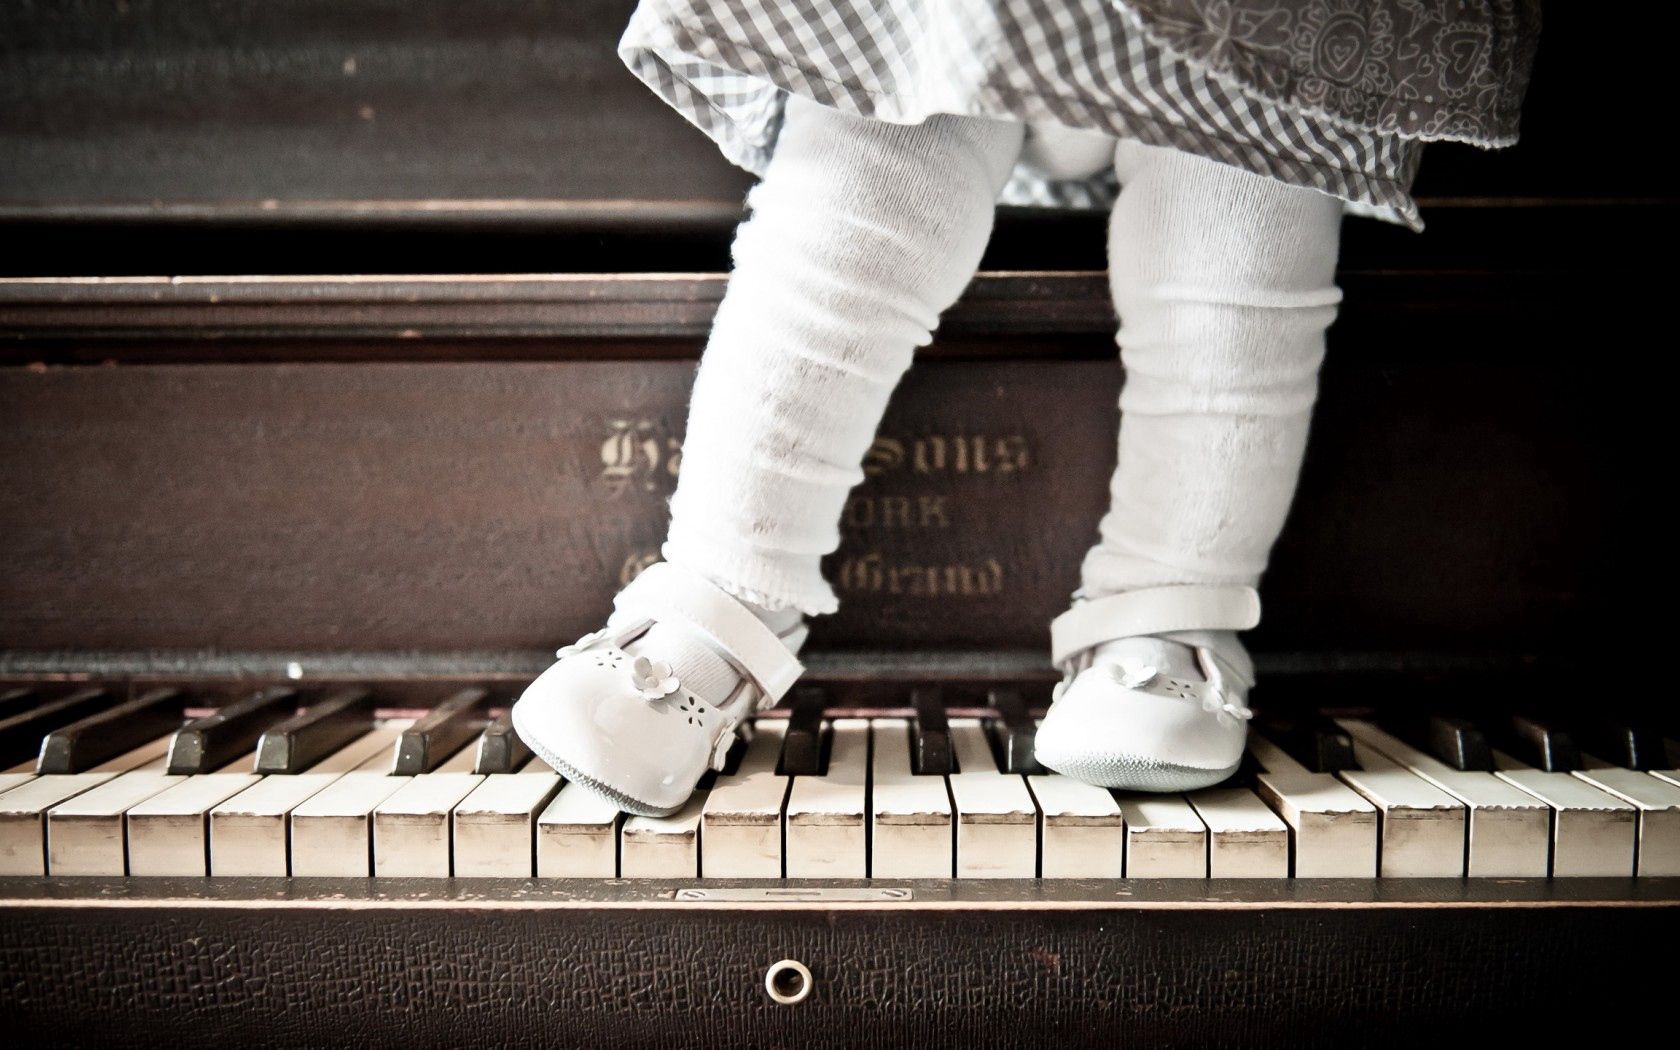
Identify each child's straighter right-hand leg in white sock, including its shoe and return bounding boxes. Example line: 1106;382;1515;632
1038;141;1341;790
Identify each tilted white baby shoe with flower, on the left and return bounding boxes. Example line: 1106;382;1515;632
512;561;810;816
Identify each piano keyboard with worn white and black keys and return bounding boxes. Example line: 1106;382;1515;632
0;689;1680;880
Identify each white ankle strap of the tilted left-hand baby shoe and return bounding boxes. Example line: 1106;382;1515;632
613;561;805;707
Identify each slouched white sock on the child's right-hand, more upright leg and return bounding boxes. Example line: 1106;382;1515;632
1080;139;1341;596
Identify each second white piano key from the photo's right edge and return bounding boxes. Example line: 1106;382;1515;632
1494;751;1638;879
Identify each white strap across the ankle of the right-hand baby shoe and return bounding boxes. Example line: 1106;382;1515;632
1050;585;1260;667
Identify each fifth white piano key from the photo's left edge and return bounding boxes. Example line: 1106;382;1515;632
291;735;413;879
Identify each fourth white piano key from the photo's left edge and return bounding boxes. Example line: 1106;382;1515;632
210;721;410;877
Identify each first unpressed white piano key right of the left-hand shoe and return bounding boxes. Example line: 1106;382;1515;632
701;721;790;879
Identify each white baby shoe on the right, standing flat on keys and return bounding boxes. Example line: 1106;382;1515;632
1035;586;1260;791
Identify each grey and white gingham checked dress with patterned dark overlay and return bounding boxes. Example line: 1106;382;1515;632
618;0;1541;230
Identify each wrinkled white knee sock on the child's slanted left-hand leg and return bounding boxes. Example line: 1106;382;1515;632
660;96;1023;613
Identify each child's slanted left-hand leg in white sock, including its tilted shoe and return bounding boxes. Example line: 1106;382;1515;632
514;97;1023;813
